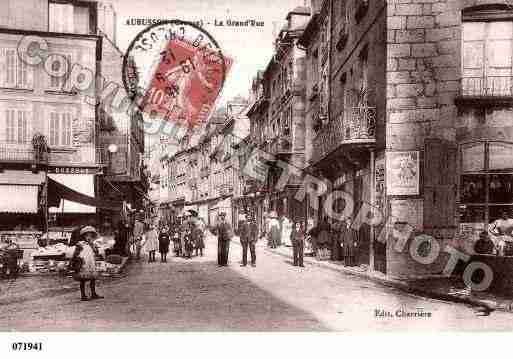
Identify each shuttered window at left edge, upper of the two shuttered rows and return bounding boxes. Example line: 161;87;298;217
0;48;34;89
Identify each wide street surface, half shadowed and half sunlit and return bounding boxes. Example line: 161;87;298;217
0;238;513;331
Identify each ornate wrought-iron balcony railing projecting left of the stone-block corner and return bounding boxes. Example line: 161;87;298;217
312;106;376;162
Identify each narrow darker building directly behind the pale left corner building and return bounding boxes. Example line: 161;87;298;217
97;22;146;224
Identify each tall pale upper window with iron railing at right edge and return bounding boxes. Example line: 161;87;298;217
462;21;513;96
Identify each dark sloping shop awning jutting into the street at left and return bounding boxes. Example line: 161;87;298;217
48;175;123;213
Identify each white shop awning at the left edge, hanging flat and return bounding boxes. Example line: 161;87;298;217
0;184;39;213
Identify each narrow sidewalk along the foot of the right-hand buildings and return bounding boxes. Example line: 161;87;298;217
262;245;513;313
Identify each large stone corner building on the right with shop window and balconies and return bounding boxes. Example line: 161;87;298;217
292;0;513;277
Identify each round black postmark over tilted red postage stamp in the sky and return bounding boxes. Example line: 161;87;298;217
122;20;232;128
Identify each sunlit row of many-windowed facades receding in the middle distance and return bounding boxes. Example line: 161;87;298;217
161;99;249;225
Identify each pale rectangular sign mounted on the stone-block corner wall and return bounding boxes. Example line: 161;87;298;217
386;151;420;196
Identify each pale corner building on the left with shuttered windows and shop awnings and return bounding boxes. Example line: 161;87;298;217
0;0;144;236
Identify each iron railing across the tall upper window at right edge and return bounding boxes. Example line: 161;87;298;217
460;76;513;98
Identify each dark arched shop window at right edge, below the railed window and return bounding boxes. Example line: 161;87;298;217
459;141;513;225
